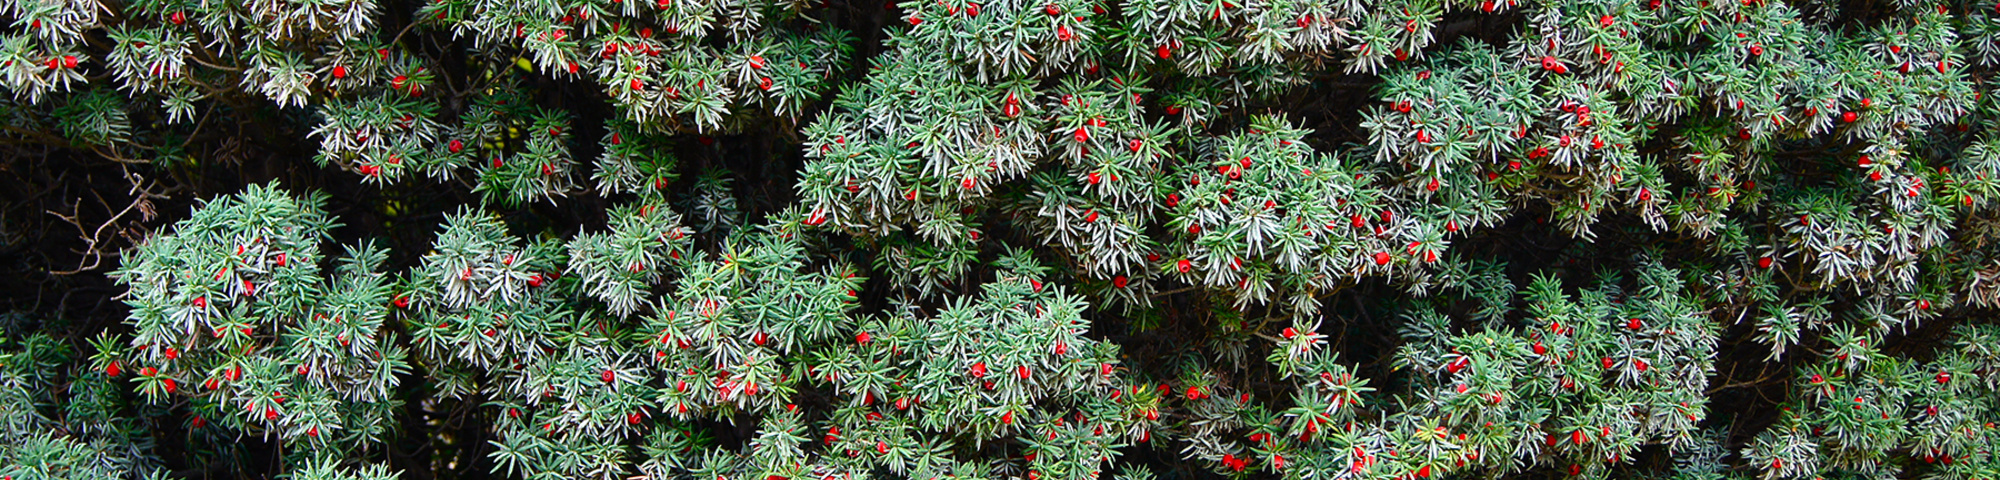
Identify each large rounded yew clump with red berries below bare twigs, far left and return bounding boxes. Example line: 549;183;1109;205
111;184;408;448
